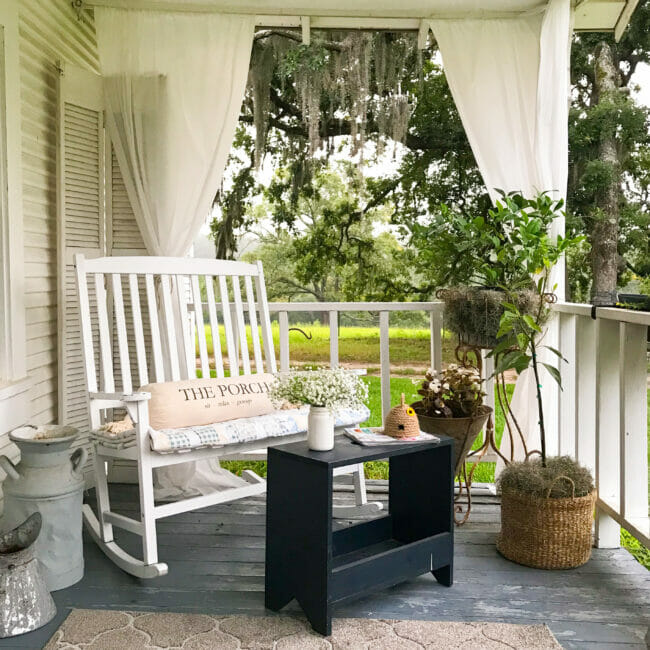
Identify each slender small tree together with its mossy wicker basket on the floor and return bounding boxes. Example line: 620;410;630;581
490;239;596;569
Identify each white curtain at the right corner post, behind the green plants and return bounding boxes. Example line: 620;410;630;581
431;0;573;474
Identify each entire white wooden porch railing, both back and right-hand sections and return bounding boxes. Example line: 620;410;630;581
224;302;650;548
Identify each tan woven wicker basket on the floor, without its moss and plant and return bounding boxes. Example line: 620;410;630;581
497;477;596;569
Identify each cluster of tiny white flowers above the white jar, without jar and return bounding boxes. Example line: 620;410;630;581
269;369;368;409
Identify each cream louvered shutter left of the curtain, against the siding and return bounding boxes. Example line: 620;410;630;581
57;66;105;484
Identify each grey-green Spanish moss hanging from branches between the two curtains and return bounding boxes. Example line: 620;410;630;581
244;30;422;167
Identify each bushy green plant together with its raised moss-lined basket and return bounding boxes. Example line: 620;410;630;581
413;192;566;348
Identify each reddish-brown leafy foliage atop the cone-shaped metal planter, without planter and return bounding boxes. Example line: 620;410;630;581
415;363;485;418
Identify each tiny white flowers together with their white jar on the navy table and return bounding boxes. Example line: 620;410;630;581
269;369;368;451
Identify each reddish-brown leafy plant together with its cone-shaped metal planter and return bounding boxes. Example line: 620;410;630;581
411;364;492;476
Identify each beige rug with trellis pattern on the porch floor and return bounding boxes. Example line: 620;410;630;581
44;609;562;650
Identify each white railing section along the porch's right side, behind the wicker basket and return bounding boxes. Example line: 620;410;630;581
553;303;650;548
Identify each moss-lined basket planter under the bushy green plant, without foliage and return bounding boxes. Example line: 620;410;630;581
436;287;540;349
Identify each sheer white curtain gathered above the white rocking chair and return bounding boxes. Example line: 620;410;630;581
95;7;255;256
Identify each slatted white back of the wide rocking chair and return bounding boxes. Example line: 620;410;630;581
75;255;276;393
